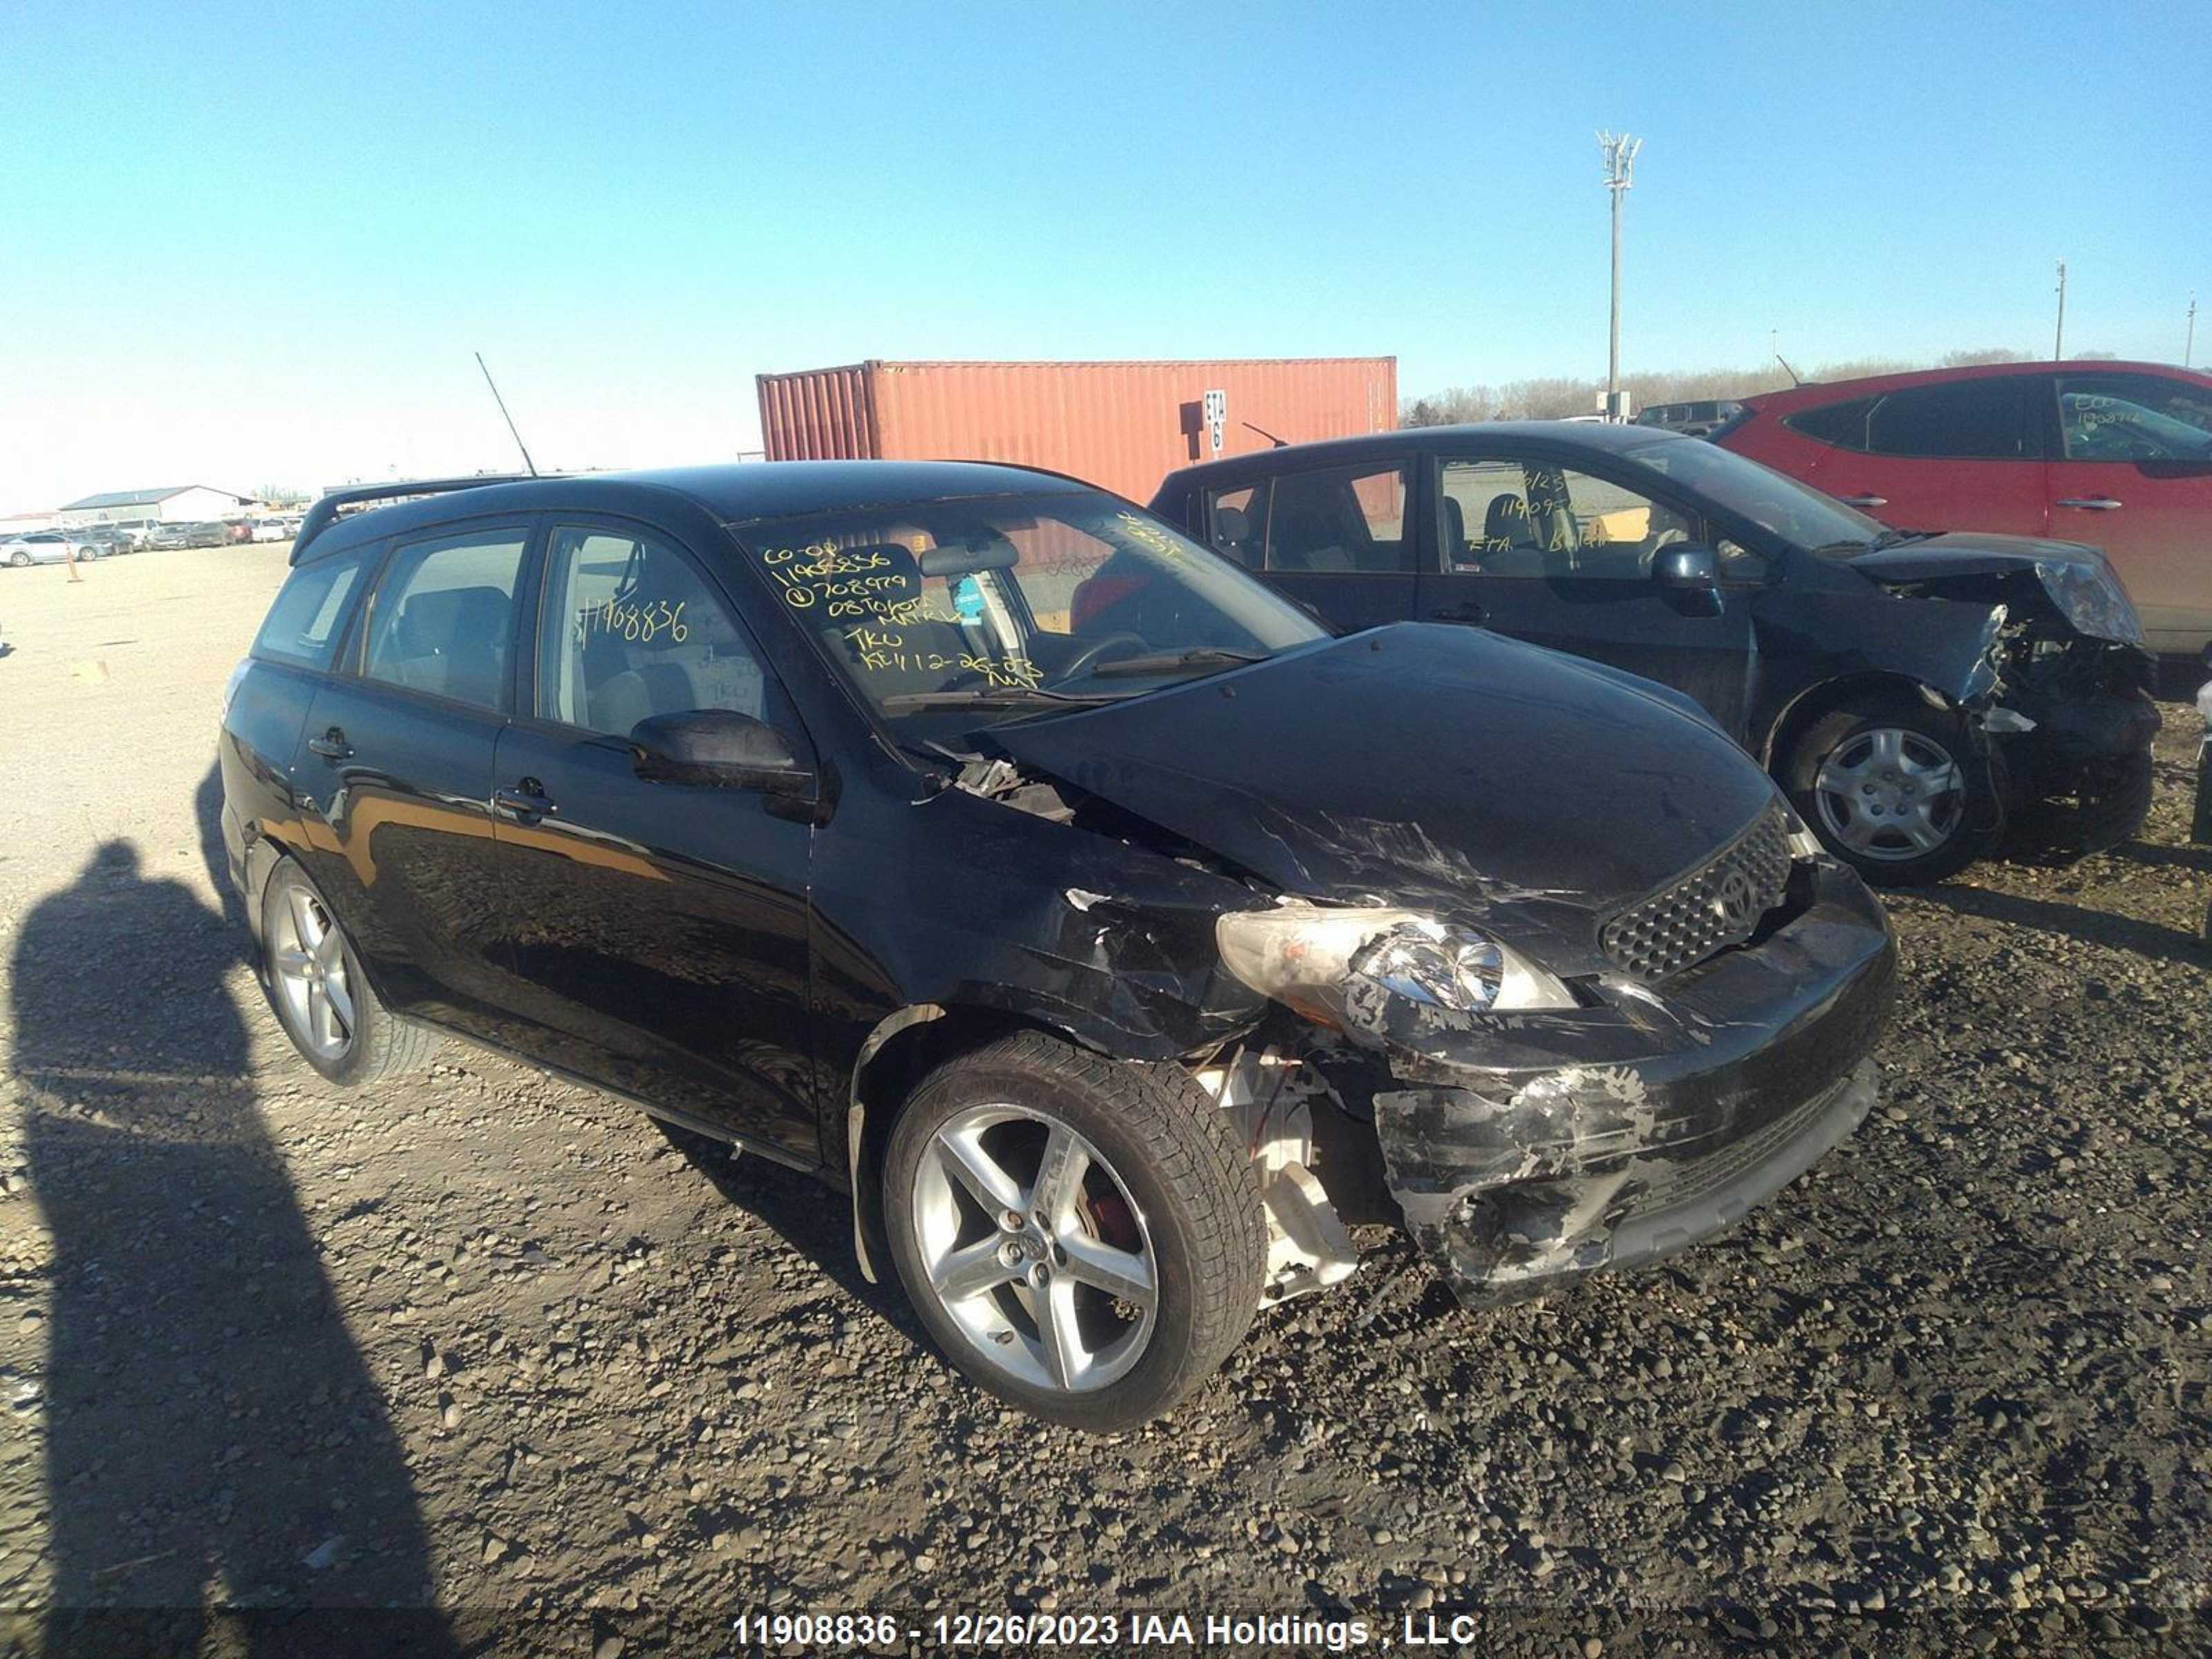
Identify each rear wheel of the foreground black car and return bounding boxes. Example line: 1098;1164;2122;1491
261;859;435;1088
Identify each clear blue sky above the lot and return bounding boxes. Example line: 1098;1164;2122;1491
0;0;2212;500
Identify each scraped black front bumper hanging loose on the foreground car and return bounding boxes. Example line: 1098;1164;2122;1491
1374;861;1895;1307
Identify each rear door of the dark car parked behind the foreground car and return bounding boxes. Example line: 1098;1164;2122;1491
1192;456;1420;632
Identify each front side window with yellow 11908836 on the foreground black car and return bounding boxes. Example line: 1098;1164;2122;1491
538;529;770;737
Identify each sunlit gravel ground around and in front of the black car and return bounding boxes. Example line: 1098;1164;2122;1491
0;546;2212;1659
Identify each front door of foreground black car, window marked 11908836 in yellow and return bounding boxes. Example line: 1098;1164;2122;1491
494;516;821;1165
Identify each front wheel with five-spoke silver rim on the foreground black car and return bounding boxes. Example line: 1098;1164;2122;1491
883;1031;1268;1434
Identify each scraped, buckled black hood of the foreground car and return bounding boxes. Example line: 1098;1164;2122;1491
984;624;1774;971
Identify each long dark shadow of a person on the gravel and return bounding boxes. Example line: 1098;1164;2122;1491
11;845;453;1655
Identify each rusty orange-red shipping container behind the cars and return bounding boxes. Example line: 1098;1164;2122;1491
759;356;1398;500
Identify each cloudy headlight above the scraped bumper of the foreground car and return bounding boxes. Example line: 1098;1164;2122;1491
1215;903;1577;1031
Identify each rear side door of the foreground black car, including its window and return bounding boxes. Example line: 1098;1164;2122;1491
292;520;529;1038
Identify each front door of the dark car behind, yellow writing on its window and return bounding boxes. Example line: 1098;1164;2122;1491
1420;447;1765;737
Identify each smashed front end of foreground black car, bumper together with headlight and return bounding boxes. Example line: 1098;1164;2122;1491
1224;807;1895;1305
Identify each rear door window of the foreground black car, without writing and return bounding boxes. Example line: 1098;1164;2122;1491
361;529;529;710
